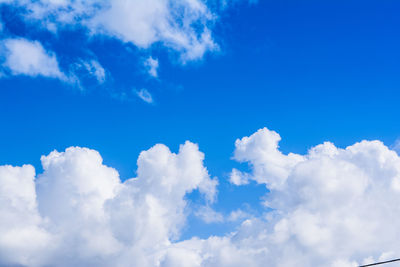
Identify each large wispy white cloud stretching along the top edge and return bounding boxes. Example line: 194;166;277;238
6;0;217;62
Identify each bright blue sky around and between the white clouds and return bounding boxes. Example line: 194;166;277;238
0;0;400;266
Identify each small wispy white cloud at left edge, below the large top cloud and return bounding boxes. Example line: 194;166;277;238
2;39;66;80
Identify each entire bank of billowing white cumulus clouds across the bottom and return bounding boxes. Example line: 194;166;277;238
0;128;400;267
